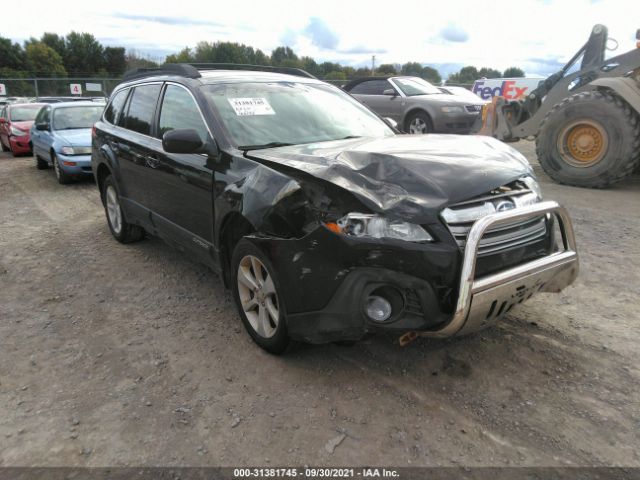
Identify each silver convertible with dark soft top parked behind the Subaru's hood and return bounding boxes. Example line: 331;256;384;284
344;77;484;134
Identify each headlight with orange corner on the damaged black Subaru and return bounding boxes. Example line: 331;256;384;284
325;213;433;242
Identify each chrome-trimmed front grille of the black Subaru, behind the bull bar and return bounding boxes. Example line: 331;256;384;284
442;182;547;256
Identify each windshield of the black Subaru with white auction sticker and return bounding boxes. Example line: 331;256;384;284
202;82;394;149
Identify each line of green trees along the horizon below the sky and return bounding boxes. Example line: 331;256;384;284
0;32;524;84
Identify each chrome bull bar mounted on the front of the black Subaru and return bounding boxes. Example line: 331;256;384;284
418;201;579;343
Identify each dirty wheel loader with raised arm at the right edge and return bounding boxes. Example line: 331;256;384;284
477;25;640;188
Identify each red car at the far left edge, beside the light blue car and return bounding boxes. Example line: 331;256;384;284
0;103;45;157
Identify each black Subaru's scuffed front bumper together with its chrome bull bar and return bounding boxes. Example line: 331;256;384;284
253;202;578;343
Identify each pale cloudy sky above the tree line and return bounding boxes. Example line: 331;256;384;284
5;0;640;77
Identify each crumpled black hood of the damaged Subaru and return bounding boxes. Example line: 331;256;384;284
247;134;533;222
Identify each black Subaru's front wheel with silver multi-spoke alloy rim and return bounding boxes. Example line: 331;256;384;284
231;238;289;355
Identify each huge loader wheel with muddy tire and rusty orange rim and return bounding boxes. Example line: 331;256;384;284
536;91;640;188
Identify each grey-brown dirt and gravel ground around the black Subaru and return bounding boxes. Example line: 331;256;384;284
0;143;640;466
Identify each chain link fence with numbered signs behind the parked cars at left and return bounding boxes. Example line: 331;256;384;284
0;77;121;99
